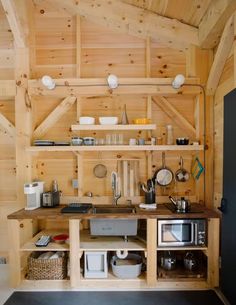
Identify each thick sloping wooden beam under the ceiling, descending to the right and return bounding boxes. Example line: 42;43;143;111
50;0;199;49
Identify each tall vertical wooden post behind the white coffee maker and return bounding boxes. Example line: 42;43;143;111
15;48;32;206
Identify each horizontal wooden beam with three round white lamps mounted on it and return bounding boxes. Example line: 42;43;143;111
28;78;200;97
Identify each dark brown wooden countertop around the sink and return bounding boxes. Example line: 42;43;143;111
7;204;220;219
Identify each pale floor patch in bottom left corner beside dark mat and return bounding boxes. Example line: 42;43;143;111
0;264;14;305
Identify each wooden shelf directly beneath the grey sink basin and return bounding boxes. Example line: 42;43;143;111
80;230;146;251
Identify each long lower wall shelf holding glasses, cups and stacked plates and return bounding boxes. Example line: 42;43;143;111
26;145;203;152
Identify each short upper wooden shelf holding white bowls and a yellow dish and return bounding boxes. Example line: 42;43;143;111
71;124;156;131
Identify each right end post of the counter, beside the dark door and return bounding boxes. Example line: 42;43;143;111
207;218;220;288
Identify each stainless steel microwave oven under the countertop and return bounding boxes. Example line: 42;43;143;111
157;219;207;247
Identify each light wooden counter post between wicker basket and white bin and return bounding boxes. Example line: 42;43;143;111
69;219;80;288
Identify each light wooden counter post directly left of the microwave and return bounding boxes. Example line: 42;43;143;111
147;219;157;287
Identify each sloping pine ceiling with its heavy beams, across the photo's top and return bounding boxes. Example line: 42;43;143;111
0;0;236;50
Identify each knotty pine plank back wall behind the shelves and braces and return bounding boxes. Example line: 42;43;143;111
0;1;211;252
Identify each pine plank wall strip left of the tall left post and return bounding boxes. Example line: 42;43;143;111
0;5;19;256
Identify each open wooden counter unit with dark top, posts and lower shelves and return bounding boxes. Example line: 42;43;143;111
8;204;220;290
